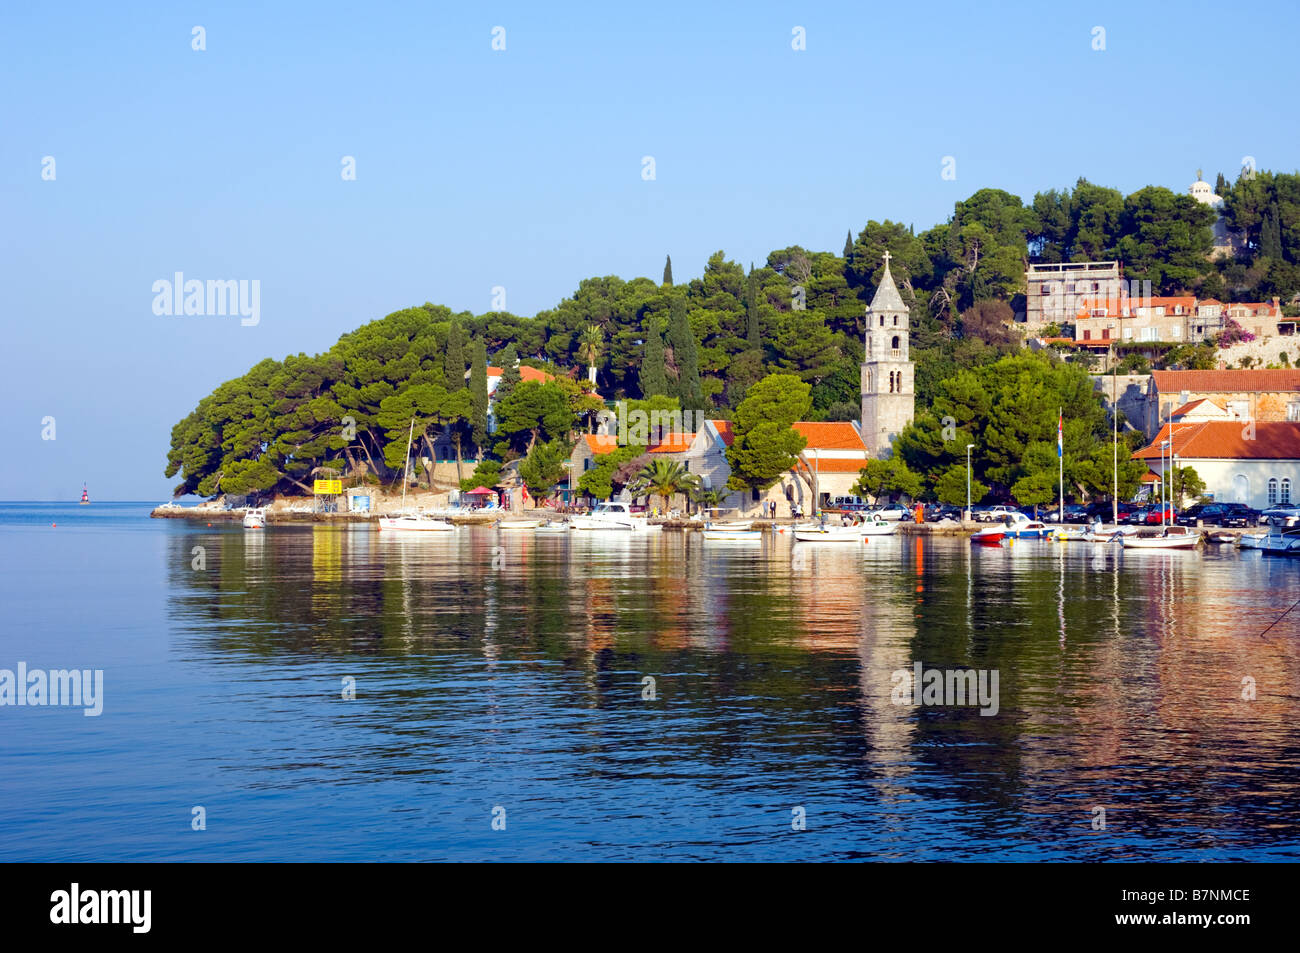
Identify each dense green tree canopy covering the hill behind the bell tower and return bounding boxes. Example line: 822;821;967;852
166;170;1300;495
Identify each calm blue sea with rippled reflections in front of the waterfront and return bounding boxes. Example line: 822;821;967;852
0;503;1300;861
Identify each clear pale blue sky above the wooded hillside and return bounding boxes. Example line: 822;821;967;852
0;1;1300;499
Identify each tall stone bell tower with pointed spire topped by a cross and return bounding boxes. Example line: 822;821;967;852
862;251;917;459
